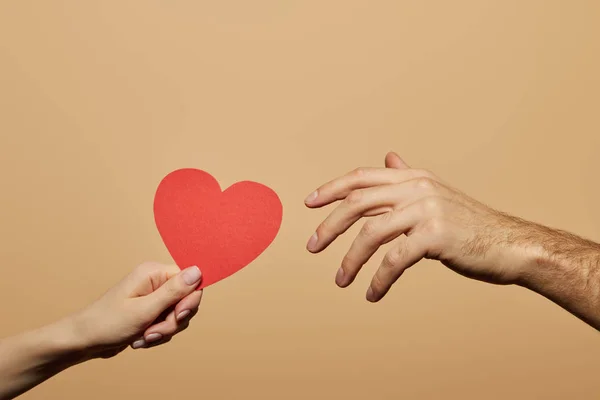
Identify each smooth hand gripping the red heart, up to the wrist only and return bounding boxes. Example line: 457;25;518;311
73;263;202;358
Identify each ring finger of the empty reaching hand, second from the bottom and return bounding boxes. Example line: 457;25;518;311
336;202;423;287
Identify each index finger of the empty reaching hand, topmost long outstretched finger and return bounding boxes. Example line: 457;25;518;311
304;168;437;208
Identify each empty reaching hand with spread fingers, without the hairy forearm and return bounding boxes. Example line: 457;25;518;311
305;153;547;302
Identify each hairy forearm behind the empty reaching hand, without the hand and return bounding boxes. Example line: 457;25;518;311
520;227;600;330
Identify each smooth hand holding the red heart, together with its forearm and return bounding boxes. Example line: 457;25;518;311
0;263;202;400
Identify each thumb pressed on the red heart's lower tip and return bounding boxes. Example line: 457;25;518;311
146;266;202;316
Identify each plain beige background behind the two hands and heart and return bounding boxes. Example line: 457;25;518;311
0;0;600;399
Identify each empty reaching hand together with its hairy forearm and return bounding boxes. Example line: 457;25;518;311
305;153;600;327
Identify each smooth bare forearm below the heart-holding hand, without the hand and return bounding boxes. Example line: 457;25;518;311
0;319;84;400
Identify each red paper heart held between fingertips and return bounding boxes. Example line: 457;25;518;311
154;168;283;289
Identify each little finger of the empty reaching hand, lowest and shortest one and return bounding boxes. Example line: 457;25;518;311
367;234;428;303
